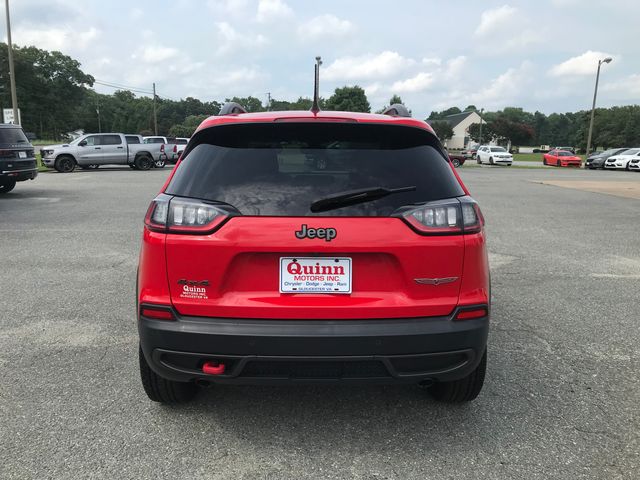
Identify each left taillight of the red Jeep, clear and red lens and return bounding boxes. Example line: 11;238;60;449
144;194;228;234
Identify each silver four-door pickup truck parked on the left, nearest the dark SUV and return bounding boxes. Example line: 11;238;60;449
40;133;164;173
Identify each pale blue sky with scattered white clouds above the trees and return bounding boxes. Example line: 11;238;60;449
5;0;640;118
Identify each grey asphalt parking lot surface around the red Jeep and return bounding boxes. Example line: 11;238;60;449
0;167;640;479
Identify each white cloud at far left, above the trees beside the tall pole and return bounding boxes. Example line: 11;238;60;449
12;25;101;53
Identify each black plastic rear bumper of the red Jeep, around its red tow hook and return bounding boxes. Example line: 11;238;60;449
138;315;489;384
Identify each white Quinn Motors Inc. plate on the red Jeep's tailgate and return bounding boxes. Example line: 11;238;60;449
280;257;351;293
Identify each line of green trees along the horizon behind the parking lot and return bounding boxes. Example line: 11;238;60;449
0;43;640;147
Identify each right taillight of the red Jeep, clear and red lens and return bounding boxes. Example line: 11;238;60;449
402;197;484;235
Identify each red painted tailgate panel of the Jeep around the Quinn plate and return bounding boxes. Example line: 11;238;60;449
166;216;464;319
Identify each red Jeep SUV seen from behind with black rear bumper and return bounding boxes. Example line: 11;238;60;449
137;104;490;403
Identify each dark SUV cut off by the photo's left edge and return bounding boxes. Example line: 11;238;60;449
0;123;38;194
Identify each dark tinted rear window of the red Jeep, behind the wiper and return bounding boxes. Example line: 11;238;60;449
166;123;464;216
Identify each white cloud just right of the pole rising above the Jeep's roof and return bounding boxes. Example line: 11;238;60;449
322;50;416;81
